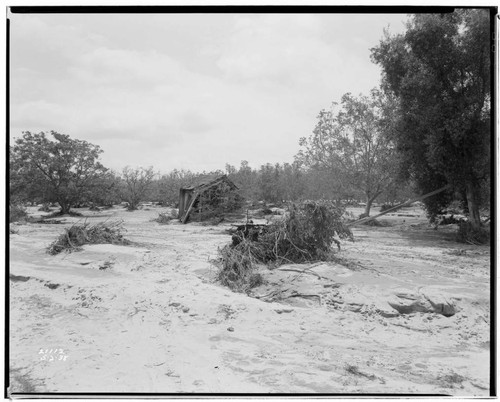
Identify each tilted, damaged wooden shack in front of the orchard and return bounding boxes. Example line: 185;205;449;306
179;175;244;223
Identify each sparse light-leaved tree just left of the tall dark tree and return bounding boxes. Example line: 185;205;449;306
297;89;395;216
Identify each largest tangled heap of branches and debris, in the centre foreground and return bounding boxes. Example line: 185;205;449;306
218;201;353;292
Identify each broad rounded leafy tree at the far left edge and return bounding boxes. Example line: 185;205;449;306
10;131;107;214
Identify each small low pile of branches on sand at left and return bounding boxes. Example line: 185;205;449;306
47;221;130;255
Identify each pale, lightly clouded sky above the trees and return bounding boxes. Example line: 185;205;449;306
8;14;407;173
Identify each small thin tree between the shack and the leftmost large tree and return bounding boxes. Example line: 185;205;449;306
122;166;156;211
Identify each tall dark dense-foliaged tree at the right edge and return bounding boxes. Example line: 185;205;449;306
372;9;491;229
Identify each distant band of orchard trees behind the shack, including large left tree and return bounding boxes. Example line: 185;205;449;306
9;131;410;214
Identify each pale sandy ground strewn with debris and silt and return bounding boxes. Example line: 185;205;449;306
9;207;490;396
